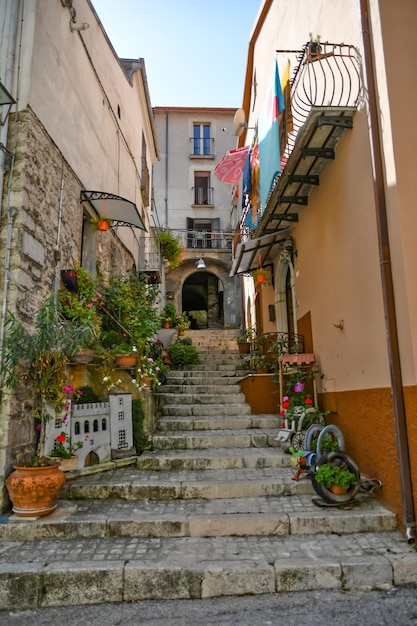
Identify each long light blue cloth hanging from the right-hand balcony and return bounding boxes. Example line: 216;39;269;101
258;60;285;212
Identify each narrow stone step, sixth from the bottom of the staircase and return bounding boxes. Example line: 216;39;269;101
157;414;280;432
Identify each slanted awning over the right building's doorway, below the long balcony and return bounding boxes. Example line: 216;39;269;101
229;228;290;276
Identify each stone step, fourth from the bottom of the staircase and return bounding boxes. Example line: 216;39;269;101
137;448;291;471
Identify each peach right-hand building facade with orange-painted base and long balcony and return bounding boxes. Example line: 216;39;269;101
234;0;417;537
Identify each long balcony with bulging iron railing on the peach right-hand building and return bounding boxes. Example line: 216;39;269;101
238;42;363;241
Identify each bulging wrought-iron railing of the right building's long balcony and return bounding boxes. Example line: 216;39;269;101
236;42;363;241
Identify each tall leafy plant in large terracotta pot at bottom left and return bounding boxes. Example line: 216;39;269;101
3;294;93;516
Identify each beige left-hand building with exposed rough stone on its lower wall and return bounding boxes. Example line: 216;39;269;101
0;0;158;508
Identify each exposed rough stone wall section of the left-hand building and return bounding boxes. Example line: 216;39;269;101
0;109;138;508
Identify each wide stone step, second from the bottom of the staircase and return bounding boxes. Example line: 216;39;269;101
0;495;397;541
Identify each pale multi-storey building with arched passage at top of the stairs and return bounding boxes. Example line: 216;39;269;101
154;107;242;328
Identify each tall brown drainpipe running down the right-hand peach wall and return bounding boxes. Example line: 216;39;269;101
360;0;415;544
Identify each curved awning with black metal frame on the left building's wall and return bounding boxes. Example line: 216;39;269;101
80;190;146;231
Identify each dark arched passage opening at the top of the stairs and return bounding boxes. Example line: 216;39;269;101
182;271;224;329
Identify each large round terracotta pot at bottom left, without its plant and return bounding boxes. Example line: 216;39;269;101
5;463;66;517
